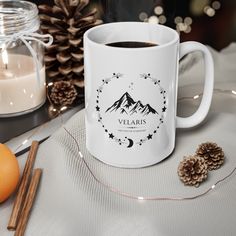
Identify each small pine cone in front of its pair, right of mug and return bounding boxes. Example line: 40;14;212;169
178;156;208;187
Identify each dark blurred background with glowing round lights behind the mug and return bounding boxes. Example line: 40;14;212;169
32;0;236;50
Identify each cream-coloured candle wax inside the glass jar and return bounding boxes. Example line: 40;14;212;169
0;54;46;116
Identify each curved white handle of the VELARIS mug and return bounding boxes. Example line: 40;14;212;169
176;41;214;128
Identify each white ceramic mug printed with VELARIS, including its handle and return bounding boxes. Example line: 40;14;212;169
84;22;214;168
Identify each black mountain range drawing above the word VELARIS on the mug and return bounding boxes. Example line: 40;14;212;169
106;92;158;116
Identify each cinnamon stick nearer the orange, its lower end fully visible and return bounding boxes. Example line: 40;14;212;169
7;141;39;230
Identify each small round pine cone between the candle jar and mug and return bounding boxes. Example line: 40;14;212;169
49;81;77;106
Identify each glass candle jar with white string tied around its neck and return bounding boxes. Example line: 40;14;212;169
0;0;52;117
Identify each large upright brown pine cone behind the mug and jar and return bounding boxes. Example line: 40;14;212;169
39;0;101;87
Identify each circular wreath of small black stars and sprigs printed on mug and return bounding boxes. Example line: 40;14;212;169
95;73;167;147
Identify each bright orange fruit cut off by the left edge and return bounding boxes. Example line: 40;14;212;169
0;143;20;203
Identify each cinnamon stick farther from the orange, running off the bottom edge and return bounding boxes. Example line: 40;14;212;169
15;169;42;236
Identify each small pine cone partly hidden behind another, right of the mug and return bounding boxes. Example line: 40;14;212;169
196;142;225;170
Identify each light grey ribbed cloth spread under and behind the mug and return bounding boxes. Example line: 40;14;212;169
0;44;236;236
